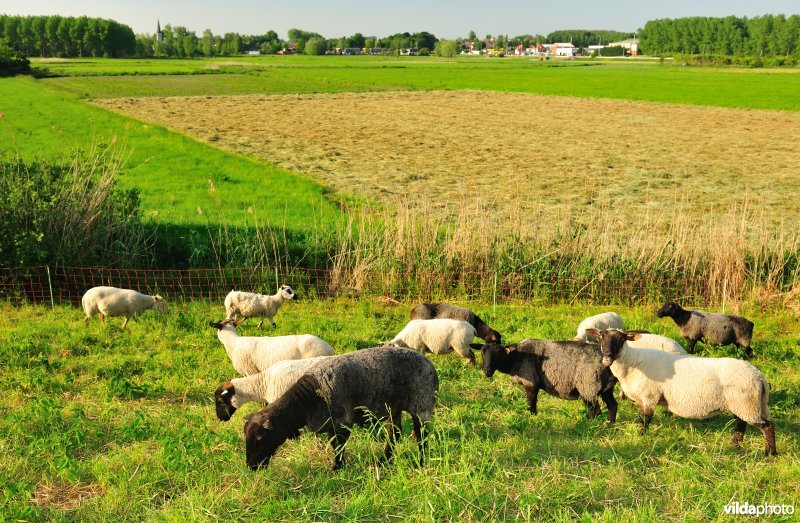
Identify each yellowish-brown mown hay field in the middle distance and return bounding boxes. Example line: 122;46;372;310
95;91;800;241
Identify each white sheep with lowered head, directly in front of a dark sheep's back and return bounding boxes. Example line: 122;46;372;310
383;319;475;364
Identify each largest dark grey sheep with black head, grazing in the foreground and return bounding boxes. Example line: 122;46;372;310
244;347;439;470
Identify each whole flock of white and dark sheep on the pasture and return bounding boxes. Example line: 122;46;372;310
82;285;777;469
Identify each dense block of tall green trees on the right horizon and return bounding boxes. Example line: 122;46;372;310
639;15;800;56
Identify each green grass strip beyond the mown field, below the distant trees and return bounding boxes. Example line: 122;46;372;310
37;56;800;111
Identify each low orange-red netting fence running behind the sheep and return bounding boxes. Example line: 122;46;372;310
0;266;711;305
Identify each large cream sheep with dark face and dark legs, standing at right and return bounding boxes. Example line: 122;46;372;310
593;329;777;456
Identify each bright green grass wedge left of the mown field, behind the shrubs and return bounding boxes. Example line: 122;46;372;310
0;77;338;230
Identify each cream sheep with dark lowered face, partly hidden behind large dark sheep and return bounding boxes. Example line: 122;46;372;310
214;356;330;421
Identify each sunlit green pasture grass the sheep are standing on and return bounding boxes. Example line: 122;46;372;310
0;301;800;521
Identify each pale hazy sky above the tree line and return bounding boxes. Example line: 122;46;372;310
6;0;800;38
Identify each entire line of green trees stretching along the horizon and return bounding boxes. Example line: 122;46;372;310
0;15;800;58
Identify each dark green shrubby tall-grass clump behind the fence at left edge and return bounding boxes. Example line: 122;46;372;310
0;140;155;267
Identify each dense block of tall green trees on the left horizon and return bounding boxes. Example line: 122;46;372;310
0;15;136;58
